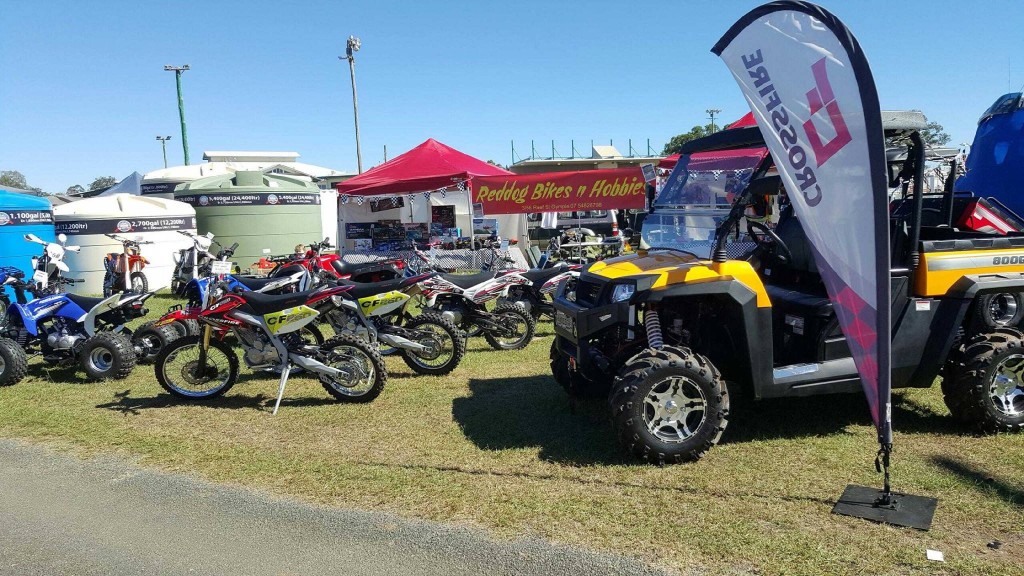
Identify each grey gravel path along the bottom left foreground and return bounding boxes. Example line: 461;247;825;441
0;440;658;576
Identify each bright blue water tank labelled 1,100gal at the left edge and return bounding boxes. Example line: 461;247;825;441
0;190;54;293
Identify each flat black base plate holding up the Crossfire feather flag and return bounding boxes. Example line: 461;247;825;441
833;484;939;530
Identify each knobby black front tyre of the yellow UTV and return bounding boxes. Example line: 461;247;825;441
608;346;729;465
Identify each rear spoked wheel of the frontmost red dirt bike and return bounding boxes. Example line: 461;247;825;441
317;334;387;403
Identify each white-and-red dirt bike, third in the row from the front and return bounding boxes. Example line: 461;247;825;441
417;264;537;349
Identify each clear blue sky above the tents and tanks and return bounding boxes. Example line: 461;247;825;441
0;0;1024;192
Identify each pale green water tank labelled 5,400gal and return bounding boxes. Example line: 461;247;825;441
174;171;324;270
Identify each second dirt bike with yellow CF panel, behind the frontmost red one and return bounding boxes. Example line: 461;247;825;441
324;274;466;376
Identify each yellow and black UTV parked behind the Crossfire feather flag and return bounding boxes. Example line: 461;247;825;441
551;112;1024;463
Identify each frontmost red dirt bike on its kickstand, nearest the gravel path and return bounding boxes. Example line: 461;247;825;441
156;286;387;414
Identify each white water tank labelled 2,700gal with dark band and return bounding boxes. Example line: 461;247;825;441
53;194;196;295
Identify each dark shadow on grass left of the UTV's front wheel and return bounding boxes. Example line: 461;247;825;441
452;375;632;465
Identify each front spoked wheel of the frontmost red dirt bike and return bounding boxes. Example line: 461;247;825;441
156;336;239;401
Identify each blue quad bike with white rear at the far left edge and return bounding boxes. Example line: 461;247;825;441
0;270;153;380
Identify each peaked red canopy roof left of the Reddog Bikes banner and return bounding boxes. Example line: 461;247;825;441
338;138;512;196
